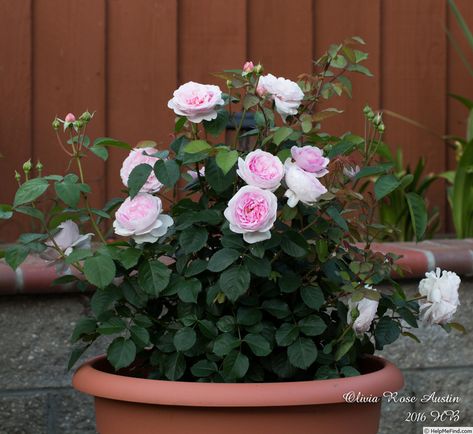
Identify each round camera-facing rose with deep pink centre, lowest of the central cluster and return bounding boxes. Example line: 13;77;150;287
223;185;278;244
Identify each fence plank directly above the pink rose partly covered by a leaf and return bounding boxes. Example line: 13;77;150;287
107;0;177;196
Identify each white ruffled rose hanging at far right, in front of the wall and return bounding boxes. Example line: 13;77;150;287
419;267;461;324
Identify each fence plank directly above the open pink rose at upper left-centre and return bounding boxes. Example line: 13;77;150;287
178;0;247;84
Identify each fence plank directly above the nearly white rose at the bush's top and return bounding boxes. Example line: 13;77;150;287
248;0;313;76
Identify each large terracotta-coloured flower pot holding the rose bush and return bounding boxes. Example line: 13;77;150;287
73;356;403;434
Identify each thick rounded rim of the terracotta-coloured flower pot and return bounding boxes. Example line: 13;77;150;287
72;356;404;407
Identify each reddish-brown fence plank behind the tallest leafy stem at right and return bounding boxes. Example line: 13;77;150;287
314;0;380;135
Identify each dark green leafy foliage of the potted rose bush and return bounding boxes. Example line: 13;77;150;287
0;37;430;382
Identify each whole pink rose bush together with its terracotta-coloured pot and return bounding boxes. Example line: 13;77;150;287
2;37;460;434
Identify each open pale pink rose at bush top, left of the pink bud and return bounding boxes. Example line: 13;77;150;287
168;81;224;124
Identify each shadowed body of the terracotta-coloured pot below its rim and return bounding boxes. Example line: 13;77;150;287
95;398;381;434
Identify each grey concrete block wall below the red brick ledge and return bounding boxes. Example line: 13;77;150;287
0;279;473;434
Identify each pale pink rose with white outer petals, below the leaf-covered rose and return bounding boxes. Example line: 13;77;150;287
113;193;174;244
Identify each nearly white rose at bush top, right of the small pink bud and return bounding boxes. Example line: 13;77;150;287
257;74;304;121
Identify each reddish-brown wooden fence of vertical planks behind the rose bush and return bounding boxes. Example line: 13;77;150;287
0;0;473;241
